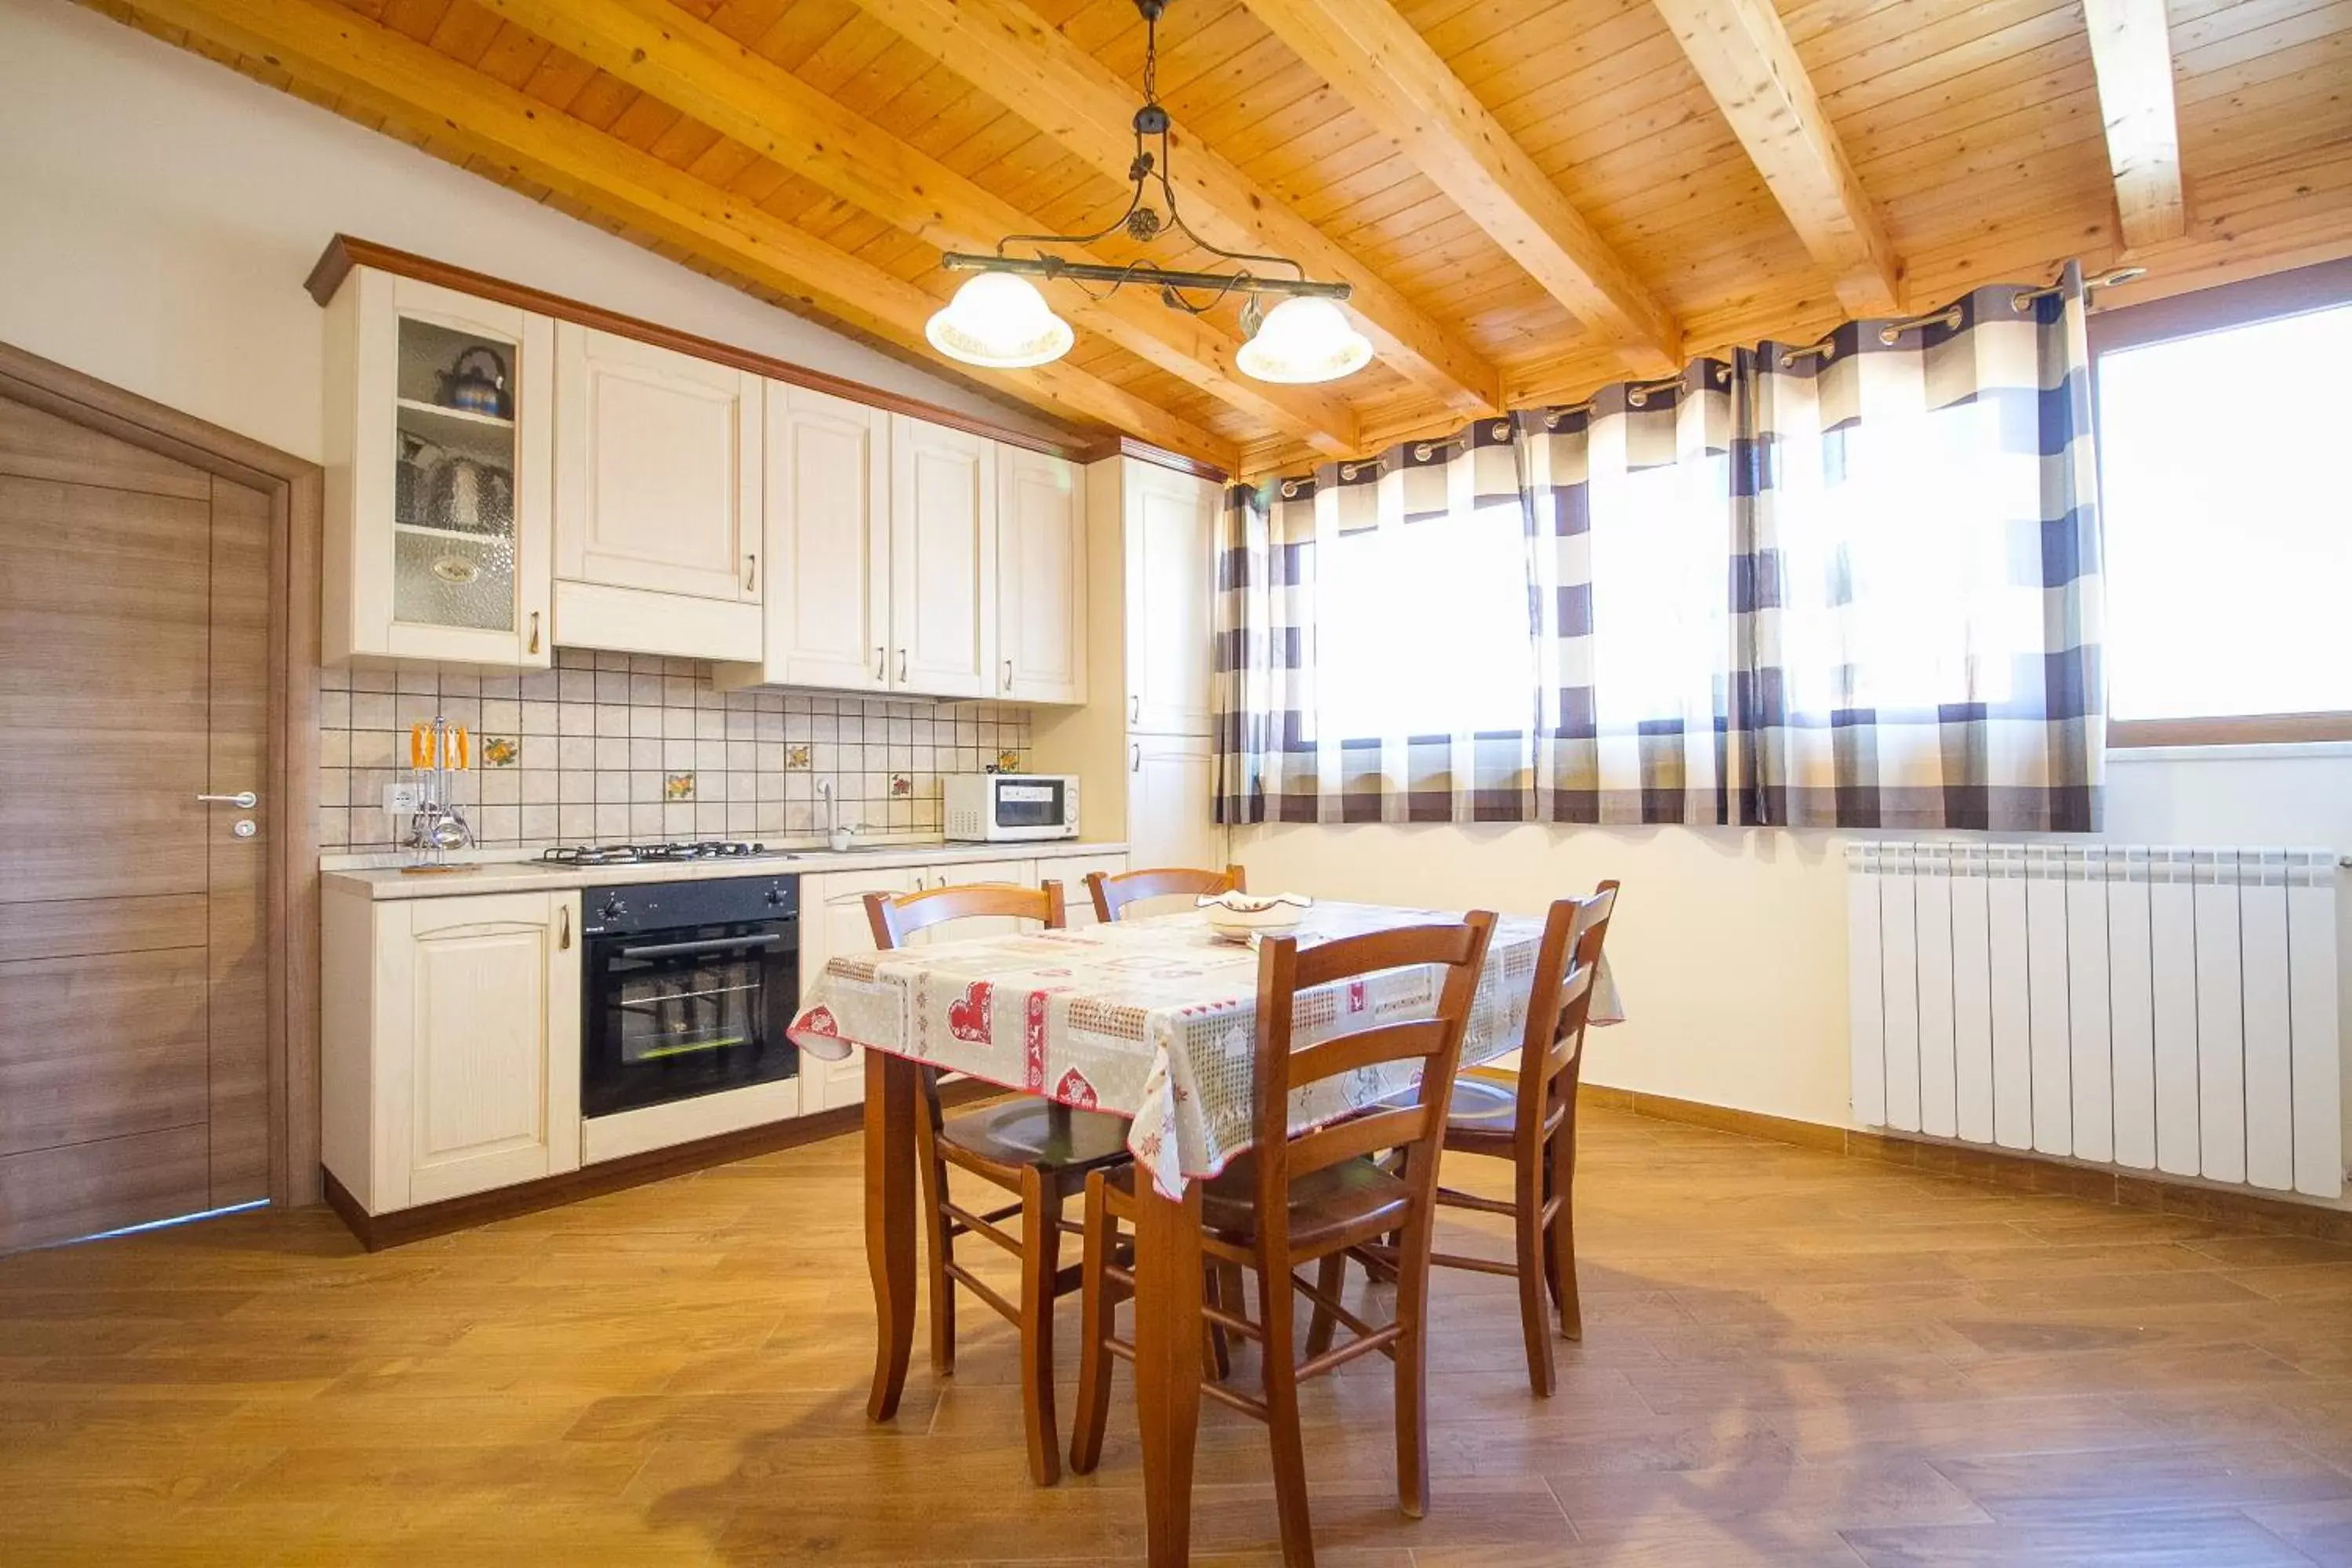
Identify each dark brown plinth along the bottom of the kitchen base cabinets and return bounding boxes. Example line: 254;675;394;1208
322;1079;1004;1253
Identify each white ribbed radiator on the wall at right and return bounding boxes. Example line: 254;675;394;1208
1846;841;2345;1196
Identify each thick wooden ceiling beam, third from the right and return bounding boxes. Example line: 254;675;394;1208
1247;0;1682;376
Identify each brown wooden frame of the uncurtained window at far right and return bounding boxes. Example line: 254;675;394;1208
2089;259;2352;750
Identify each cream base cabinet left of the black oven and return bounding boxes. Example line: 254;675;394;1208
322;891;581;1213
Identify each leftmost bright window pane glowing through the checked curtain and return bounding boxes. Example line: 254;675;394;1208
1315;501;1536;741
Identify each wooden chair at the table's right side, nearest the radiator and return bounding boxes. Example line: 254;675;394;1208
1336;881;1618;1399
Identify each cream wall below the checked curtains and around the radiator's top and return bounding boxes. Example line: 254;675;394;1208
1235;746;2352;1161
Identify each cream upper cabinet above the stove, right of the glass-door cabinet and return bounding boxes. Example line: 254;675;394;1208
555;322;764;659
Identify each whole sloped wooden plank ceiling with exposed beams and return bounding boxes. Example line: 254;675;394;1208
92;0;2352;473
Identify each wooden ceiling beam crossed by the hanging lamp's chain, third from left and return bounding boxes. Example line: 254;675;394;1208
856;0;1503;414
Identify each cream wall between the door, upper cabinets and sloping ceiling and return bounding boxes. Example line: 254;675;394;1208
0;0;1051;461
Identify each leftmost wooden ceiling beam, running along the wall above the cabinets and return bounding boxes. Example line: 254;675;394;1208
132;0;1237;470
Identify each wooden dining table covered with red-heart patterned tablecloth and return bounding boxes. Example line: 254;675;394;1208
790;900;1623;1566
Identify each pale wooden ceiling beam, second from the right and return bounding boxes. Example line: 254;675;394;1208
1653;0;1903;315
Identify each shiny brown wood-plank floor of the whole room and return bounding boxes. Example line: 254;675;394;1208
0;1109;2352;1568
